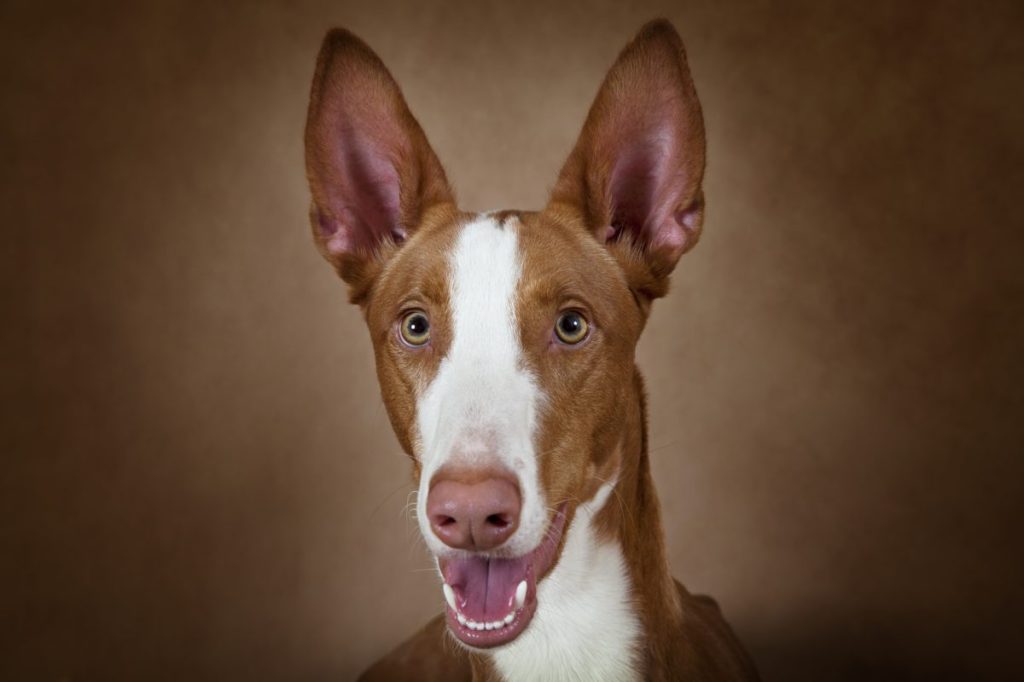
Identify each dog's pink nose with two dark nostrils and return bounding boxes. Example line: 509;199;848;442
427;470;522;552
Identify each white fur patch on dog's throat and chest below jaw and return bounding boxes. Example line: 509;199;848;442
494;484;641;682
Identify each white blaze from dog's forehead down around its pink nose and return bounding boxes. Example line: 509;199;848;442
417;216;548;555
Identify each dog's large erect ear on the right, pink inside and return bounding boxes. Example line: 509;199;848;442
550;19;705;297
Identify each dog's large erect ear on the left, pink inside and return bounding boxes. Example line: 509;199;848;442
305;29;454;297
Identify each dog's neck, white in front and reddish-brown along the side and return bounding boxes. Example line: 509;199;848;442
471;372;682;682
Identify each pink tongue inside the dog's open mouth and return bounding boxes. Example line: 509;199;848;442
444;556;529;622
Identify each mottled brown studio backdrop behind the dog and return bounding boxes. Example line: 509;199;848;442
0;0;1024;680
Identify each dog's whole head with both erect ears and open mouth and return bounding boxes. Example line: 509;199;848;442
306;23;703;648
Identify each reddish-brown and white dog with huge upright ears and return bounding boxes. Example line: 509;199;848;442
305;20;758;682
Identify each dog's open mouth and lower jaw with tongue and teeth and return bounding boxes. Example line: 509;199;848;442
437;504;565;649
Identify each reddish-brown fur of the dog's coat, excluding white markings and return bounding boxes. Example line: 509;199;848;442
306;15;757;680
